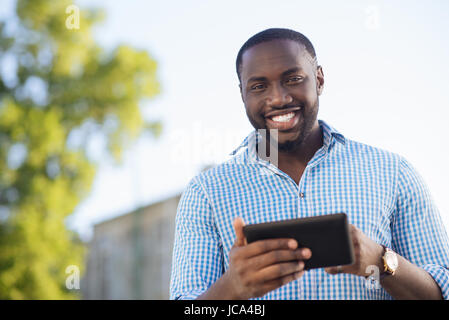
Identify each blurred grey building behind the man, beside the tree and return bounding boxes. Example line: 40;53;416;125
81;194;181;299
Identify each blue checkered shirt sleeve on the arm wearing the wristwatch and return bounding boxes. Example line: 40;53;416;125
392;158;449;300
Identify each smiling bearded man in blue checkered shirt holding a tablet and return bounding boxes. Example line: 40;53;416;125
170;29;449;299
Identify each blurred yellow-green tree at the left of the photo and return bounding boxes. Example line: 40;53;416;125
0;0;161;299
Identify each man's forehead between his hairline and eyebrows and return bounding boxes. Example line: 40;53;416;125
241;40;316;79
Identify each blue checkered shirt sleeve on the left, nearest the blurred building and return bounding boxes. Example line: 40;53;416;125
170;178;223;299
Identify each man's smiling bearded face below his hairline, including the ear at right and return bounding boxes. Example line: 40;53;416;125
240;40;324;152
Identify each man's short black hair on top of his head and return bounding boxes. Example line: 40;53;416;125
235;28;316;81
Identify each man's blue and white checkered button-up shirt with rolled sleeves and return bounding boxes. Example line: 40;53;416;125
170;120;449;300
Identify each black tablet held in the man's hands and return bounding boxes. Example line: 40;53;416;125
243;213;354;270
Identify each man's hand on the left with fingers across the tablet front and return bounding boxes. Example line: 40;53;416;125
223;218;312;299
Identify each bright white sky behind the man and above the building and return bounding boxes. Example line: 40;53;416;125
7;0;449;239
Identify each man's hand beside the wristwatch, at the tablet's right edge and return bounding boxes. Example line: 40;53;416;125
324;225;383;277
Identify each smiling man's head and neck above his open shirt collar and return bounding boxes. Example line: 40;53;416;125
236;30;324;184
